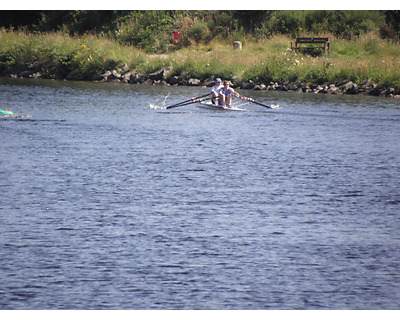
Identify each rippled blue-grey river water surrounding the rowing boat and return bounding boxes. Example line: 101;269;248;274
0;79;400;310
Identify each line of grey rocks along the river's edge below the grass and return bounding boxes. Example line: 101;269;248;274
1;65;400;98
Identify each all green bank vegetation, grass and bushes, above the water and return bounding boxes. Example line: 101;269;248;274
0;11;400;96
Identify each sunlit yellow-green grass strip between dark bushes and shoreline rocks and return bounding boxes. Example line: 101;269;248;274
0;29;400;94
